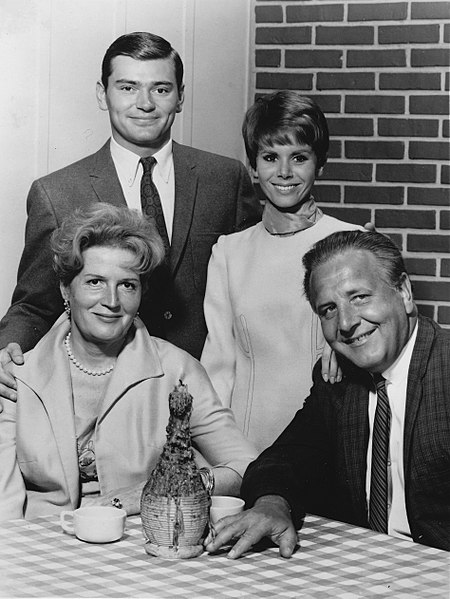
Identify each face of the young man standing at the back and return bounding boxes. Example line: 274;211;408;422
97;56;184;156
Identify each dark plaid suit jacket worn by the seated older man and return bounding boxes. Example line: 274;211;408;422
241;317;450;550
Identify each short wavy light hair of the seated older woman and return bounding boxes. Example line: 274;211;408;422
51;203;164;286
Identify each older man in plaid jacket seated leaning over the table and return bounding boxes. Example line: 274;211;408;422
206;231;450;558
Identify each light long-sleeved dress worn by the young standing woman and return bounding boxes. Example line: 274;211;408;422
201;215;360;451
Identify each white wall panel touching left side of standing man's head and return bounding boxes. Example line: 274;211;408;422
47;0;118;172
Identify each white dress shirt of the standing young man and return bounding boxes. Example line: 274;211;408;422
110;137;175;241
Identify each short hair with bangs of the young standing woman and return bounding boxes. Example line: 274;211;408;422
242;90;329;169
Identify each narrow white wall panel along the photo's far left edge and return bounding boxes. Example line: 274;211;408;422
0;0;41;314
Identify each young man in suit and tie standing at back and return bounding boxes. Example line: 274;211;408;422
0;32;260;398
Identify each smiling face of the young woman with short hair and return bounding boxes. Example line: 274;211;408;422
256;141;322;212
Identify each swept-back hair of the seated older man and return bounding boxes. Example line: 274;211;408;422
303;231;406;310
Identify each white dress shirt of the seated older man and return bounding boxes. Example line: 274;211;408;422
366;324;417;541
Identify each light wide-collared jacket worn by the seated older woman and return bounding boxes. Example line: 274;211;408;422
0;315;256;519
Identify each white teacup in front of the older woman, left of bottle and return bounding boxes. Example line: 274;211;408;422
60;505;127;543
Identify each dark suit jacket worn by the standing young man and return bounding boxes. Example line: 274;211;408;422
0;142;261;358
